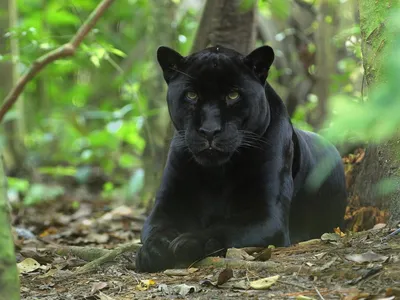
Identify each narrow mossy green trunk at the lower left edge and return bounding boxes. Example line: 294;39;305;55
0;156;20;300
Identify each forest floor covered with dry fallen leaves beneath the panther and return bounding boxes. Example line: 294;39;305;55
13;151;400;300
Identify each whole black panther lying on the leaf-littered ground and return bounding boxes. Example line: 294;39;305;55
136;46;346;272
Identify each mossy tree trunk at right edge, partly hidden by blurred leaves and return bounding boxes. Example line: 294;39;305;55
352;0;400;223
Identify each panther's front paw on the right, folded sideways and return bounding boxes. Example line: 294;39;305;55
169;233;223;267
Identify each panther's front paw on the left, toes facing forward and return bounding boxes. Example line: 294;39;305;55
136;235;175;272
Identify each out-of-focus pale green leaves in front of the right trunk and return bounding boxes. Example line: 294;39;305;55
325;11;400;143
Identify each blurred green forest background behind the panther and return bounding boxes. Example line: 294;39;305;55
0;0;400;220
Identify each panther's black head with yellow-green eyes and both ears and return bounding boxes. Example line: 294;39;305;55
157;46;274;166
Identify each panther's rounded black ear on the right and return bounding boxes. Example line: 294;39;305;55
244;46;275;84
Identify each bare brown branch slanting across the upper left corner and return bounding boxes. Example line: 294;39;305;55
0;0;115;122
